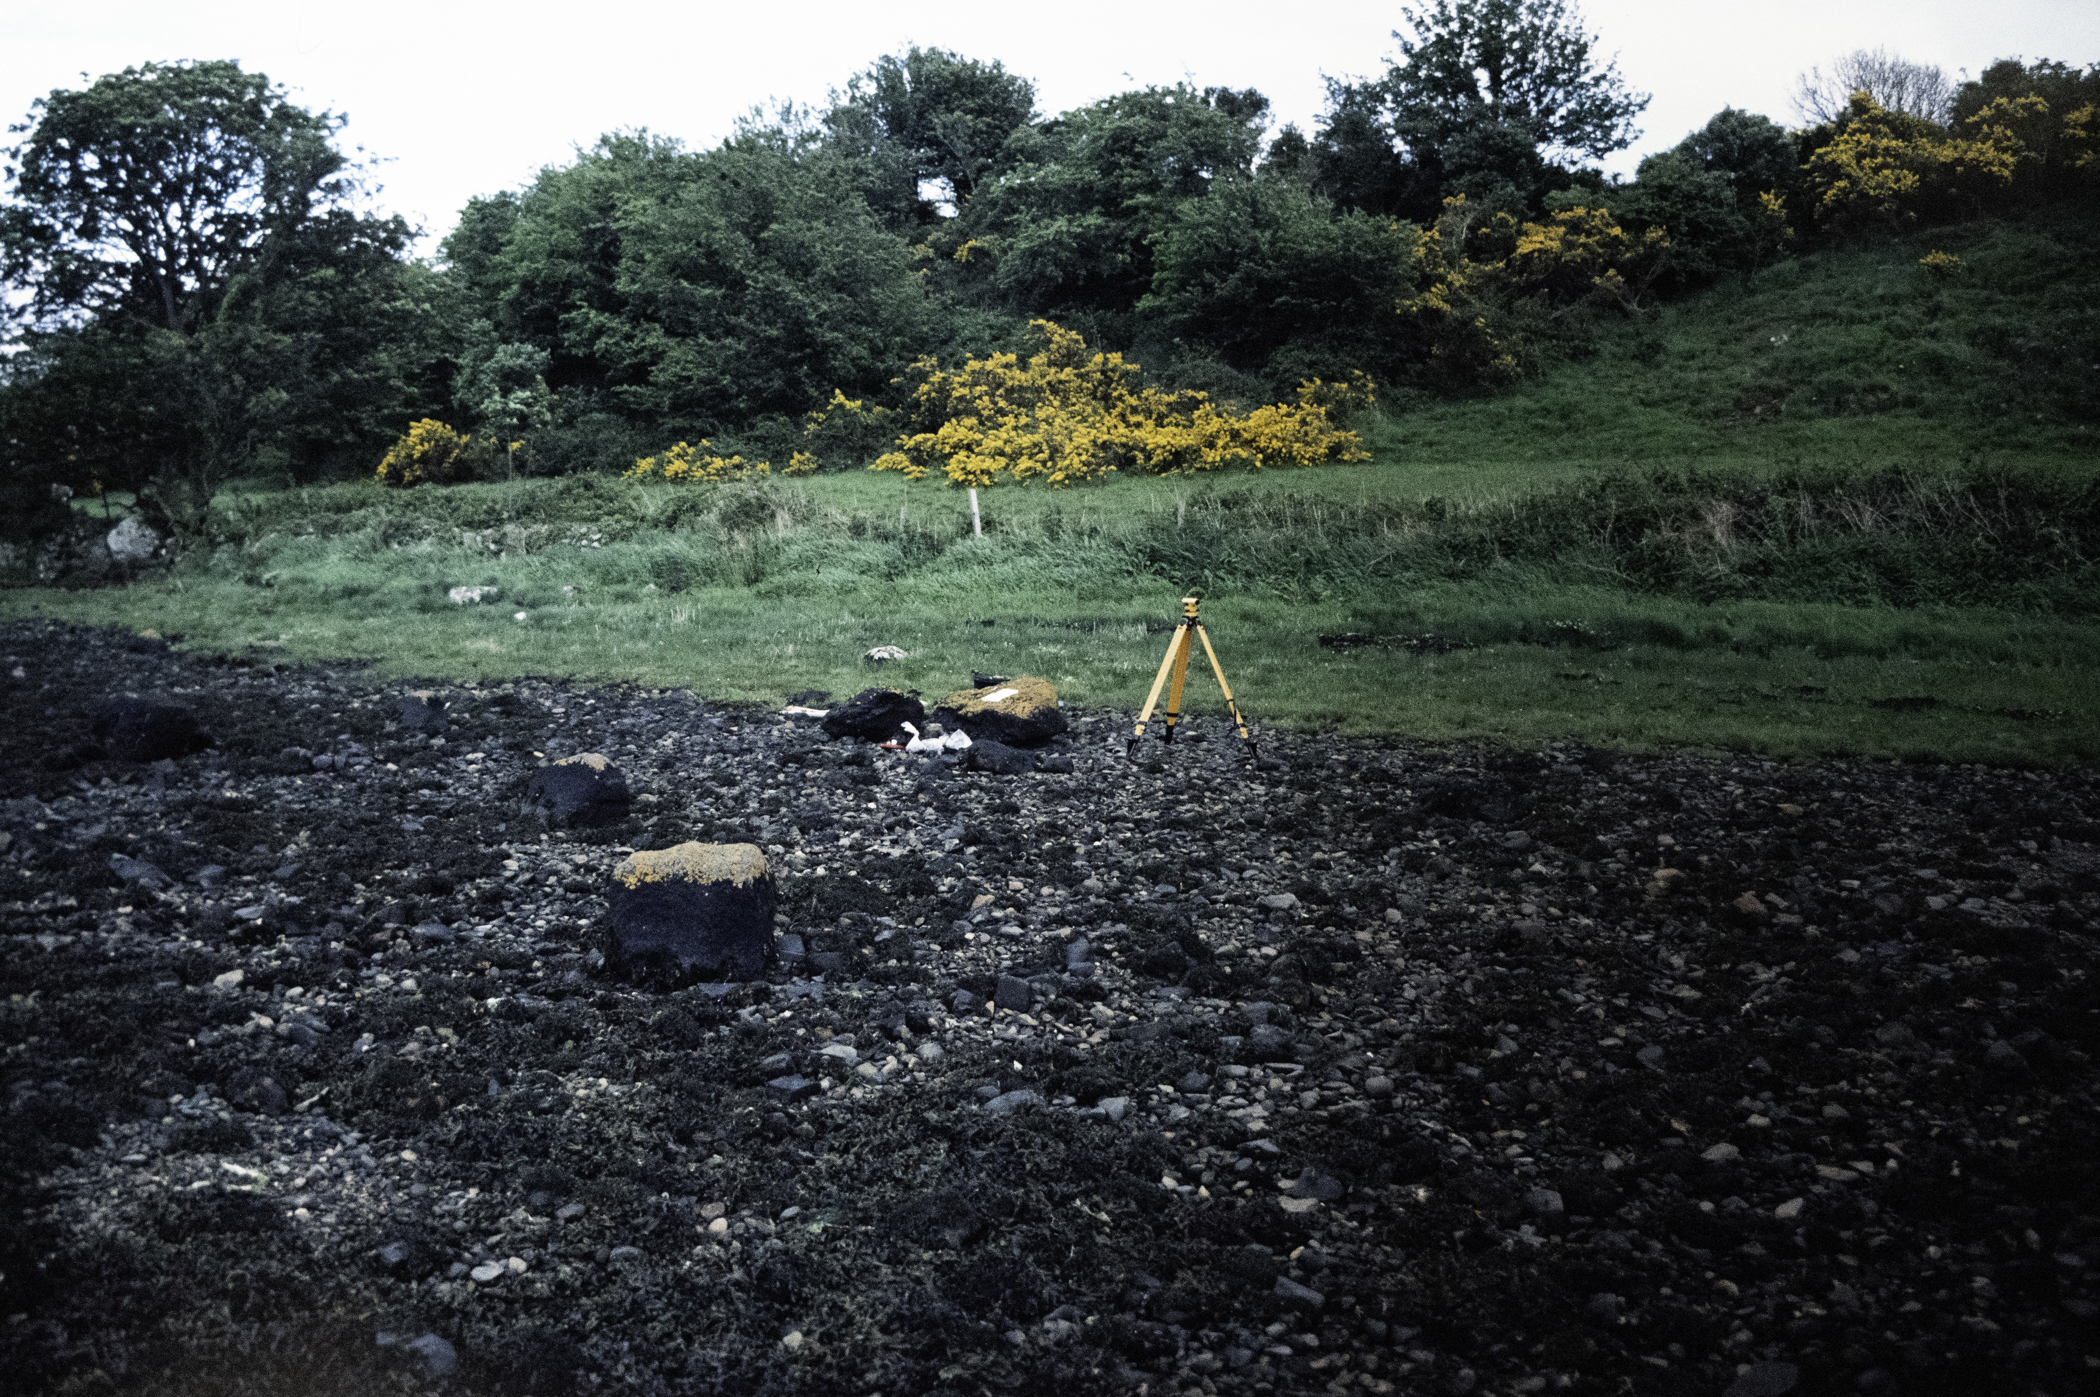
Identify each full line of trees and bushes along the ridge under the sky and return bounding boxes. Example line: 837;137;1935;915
0;0;2100;527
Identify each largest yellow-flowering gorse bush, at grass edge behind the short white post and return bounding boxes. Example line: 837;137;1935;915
869;319;1369;485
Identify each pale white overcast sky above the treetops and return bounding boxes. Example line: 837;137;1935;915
0;0;2100;246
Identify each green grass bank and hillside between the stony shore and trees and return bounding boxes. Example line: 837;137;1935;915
0;221;2100;760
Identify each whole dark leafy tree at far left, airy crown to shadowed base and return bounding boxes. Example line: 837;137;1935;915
0;63;441;516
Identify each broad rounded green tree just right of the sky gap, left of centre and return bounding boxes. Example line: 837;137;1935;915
487;124;924;437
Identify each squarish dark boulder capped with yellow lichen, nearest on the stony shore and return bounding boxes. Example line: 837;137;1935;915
605;845;777;985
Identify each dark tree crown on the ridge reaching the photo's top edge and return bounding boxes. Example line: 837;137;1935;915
1317;0;1649;218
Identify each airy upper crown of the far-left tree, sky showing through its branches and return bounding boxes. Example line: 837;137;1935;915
0;61;351;334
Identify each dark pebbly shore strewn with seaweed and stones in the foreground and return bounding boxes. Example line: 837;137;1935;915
0;622;2100;1397
